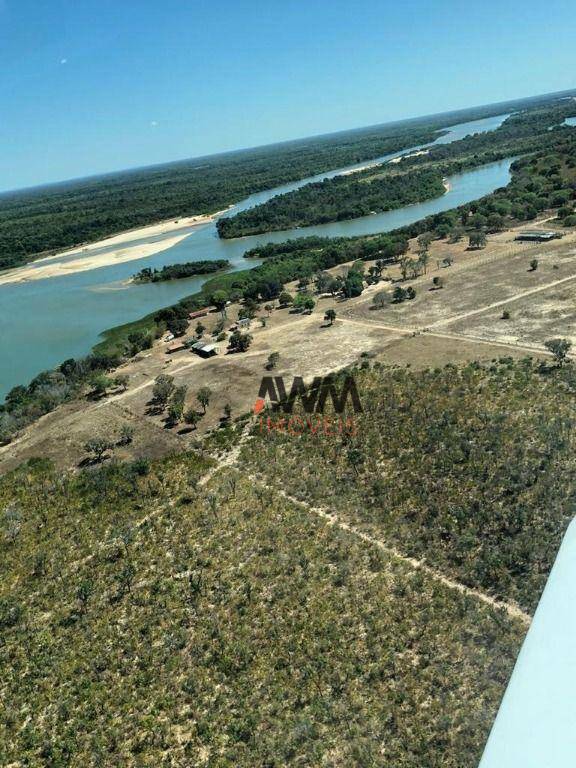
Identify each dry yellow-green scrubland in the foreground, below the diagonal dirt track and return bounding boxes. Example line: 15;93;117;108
0;424;525;768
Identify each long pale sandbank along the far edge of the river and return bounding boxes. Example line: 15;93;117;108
0;211;224;285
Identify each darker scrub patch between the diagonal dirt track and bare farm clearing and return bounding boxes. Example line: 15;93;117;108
244;356;576;611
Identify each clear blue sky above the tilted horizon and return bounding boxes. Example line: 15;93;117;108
0;0;576;189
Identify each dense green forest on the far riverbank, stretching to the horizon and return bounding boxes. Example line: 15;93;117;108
0;94;560;269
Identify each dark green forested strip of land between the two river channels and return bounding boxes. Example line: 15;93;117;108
217;103;575;238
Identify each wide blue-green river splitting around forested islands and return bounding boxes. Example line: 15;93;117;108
0;115;512;399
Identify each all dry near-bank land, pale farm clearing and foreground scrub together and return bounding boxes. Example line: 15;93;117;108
5;222;576;768
